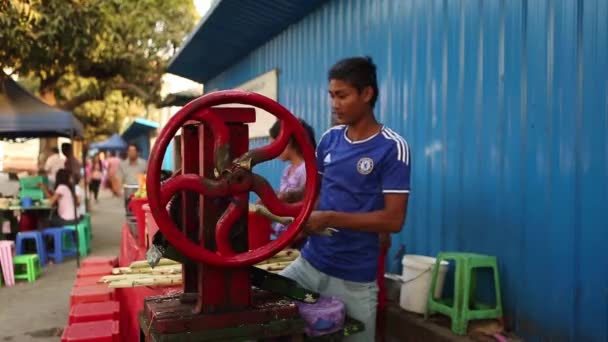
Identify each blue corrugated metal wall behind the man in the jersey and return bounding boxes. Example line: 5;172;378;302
206;0;608;341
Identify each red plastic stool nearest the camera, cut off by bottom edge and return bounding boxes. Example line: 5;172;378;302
61;320;120;342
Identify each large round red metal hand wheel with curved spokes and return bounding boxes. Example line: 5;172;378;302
146;90;318;267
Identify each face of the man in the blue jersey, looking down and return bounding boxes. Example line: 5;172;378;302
329;79;373;125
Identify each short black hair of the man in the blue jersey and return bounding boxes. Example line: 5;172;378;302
327;57;378;108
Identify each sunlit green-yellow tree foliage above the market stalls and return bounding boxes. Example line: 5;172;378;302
0;0;198;137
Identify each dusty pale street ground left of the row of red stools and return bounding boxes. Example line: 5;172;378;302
0;178;124;342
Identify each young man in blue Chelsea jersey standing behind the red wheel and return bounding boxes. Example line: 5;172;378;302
282;57;410;342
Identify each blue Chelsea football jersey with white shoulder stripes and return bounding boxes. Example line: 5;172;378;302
302;126;411;282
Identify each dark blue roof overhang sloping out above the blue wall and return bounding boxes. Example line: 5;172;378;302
168;0;327;83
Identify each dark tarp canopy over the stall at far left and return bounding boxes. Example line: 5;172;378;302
0;75;84;139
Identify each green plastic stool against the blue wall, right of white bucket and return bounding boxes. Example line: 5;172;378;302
425;253;502;335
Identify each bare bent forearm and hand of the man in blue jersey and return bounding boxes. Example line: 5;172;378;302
306;194;409;233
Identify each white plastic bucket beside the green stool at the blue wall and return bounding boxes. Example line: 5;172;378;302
399;254;449;314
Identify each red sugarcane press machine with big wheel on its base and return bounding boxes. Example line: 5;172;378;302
139;90;364;341
